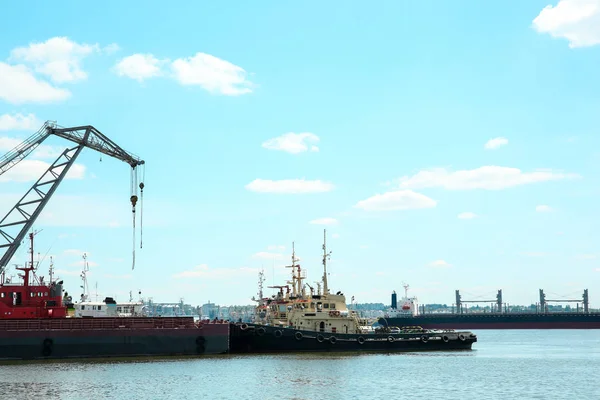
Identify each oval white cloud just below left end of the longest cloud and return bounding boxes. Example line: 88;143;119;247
354;190;437;211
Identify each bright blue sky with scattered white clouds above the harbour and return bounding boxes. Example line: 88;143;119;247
0;0;600;306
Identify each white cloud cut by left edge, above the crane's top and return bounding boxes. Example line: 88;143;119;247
0;62;71;104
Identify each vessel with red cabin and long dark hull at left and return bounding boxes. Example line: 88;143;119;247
0;233;229;360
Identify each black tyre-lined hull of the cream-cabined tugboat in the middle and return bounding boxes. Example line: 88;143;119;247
229;323;477;354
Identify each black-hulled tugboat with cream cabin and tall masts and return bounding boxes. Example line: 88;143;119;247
230;231;477;353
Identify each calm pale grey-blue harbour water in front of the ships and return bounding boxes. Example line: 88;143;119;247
0;330;600;400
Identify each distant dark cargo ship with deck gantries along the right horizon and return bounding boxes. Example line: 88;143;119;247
378;285;600;330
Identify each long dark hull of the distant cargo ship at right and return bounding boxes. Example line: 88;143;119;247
378;313;600;329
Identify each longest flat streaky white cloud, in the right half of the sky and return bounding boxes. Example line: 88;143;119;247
398;165;580;190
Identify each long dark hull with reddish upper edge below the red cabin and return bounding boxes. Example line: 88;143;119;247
0;317;229;360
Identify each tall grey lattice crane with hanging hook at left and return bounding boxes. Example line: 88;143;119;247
0;121;145;273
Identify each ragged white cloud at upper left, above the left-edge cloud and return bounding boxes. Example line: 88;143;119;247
11;37;100;83
